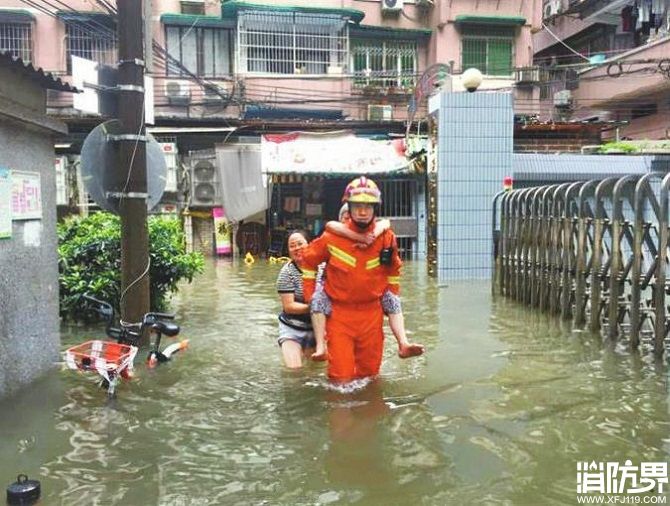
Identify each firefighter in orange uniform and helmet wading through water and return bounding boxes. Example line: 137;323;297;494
300;176;402;383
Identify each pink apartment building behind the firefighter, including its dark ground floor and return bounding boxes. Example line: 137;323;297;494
0;0;541;256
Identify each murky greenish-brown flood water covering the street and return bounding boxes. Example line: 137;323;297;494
0;260;670;506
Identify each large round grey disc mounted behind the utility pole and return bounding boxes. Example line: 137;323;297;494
81;120;167;214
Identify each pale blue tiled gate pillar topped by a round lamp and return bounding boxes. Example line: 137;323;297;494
435;91;514;283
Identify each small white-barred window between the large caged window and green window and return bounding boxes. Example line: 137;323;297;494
351;40;418;88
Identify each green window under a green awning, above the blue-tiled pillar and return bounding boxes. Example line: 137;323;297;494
461;27;514;76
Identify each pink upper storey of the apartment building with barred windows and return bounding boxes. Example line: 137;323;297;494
0;0;539;124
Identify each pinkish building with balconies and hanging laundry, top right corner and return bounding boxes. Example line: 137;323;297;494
533;0;670;140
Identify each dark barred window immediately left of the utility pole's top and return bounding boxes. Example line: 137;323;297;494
65;21;117;74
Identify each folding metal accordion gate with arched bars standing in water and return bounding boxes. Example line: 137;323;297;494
493;172;670;356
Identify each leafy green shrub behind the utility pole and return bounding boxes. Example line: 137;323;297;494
58;213;204;319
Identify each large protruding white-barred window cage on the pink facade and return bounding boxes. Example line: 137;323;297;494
238;12;348;74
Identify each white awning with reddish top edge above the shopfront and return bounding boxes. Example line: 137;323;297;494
261;132;410;175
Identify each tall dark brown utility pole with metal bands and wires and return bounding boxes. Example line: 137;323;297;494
116;0;149;322
